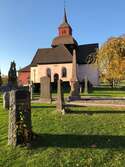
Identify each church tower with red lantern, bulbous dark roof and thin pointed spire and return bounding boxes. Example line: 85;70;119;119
52;8;78;49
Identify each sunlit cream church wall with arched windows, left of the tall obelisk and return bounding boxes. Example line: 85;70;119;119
31;63;72;83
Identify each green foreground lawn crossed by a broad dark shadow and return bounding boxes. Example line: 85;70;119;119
0;99;125;167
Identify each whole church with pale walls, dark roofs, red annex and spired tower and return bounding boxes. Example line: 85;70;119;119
18;9;99;86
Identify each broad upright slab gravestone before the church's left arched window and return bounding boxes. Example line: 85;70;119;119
40;76;52;103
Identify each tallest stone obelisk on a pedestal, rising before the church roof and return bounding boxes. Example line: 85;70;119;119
69;49;80;100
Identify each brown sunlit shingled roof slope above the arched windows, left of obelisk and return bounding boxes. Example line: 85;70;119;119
31;45;72;66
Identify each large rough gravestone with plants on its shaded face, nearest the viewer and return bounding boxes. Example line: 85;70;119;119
8;90;32;146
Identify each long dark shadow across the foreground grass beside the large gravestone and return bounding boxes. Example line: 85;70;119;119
32;134;125;149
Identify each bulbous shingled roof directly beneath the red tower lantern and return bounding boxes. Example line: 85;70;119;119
52;35;78;46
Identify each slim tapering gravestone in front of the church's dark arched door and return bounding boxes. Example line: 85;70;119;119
56;79;65;113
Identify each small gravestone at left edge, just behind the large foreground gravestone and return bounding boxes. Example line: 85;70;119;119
3;91;10;110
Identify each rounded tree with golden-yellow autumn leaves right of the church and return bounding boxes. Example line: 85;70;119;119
96;36;125;87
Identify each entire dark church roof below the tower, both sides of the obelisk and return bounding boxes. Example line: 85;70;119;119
31;43;98;66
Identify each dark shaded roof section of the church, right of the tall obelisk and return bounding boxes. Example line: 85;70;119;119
77;43;99;64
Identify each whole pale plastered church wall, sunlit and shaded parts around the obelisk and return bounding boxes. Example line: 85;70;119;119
31;63;99;86
